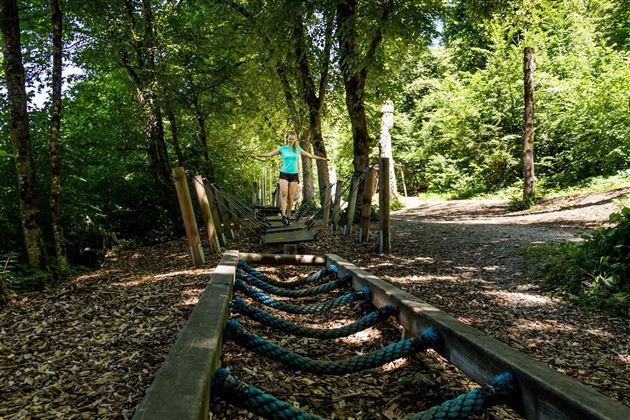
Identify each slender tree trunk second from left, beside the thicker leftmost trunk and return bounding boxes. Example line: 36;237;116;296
48;0;68;271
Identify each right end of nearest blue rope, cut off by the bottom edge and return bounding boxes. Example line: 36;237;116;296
405;372;514;420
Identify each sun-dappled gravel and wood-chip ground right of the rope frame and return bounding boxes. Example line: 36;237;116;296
308;189;630;405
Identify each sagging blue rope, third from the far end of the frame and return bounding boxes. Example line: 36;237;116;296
234;279;371;314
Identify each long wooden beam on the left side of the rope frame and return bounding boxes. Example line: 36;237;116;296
133;251;239;420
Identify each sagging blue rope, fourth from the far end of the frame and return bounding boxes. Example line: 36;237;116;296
232;297;398;339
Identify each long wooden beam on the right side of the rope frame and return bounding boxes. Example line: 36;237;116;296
326;254;630;420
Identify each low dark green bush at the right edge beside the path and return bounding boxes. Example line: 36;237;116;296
529;207;630;318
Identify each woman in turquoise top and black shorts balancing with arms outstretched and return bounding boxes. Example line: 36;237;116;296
251;131;328;225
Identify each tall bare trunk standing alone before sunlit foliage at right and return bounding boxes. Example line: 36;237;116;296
523;47;536;200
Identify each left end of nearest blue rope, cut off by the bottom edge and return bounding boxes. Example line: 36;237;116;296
212;368;321;420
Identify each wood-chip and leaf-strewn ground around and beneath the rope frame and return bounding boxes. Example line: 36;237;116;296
0;189;630;419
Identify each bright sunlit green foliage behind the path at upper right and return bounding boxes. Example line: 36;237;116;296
394;0;630;197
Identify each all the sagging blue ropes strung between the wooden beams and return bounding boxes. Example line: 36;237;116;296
212;261;514;420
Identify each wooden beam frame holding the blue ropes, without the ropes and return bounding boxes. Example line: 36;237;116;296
133;250;630;420
